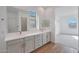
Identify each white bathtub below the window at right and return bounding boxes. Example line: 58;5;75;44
55;34;79;50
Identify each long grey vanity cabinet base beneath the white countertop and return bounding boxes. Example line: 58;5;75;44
6;31;51;53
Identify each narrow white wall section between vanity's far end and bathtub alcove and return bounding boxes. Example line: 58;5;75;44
47;7;55;42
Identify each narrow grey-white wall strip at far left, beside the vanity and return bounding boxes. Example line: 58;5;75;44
0;6;7;52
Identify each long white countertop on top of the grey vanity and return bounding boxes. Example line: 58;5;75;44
5;29;50;41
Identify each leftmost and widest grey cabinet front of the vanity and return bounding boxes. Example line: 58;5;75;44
7;39;24;53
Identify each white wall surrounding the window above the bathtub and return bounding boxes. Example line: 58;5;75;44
55;7;78;35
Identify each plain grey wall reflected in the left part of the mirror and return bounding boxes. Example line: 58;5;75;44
7;6;19;33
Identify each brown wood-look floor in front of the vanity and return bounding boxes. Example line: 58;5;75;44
32;43;61;53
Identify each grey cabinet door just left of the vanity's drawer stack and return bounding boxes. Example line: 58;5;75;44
25;36;35;53
